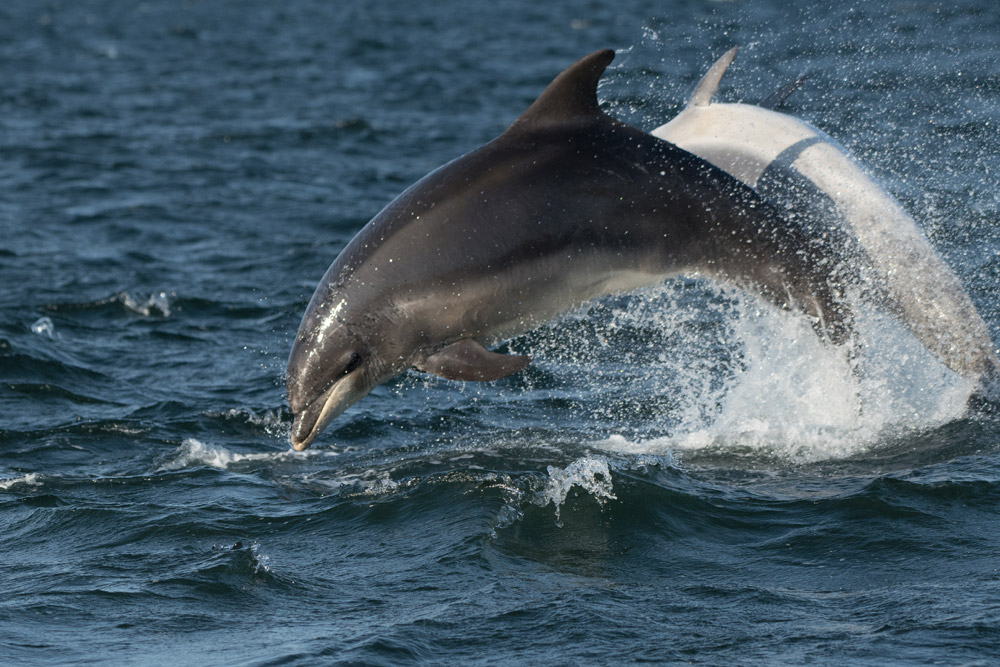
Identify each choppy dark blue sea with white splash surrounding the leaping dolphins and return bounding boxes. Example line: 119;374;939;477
0;0;1000;665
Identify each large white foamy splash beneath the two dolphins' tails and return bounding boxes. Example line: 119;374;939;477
584;288;973;463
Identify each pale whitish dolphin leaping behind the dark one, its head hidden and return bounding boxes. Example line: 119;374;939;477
653;48;1000;384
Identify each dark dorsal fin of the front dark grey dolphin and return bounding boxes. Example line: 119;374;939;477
511;49;615;129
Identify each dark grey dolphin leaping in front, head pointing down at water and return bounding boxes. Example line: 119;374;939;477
286;50;864;450
